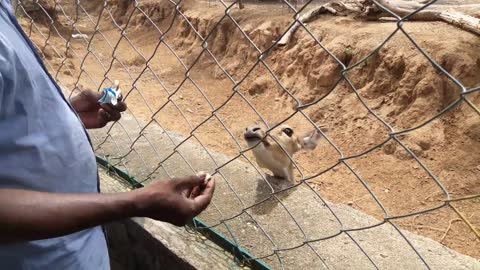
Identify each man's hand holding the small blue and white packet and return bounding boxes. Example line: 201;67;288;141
70;90;127;129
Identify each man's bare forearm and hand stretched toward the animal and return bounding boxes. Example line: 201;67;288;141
0;176;215;244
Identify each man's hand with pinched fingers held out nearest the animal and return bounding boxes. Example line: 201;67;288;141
136;175;215;226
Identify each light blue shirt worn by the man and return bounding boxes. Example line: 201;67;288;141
0;0;110;270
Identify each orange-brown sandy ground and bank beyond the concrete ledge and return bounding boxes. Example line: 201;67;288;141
17;1;480;258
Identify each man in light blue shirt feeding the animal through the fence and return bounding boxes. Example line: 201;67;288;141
0;0;214;270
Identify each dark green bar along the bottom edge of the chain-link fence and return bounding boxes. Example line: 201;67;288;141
96;156;271;270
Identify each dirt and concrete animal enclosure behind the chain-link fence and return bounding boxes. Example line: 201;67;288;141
15;0;480;269
